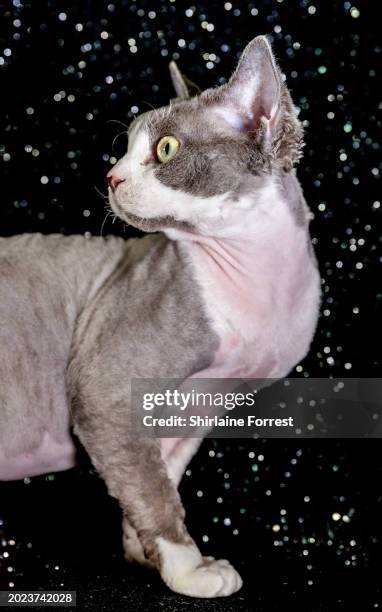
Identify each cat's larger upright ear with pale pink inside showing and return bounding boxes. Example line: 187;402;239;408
218;36;282;140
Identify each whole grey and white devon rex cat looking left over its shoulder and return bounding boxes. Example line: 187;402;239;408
0;36;320;597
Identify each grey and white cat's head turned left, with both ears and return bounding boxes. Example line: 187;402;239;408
108;36;303;235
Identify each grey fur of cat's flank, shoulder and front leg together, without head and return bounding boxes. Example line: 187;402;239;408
0;235;217;565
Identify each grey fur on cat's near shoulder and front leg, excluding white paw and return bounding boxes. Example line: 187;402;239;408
68;235;217;565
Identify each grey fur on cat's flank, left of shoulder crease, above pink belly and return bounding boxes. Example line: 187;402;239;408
0;234;124;456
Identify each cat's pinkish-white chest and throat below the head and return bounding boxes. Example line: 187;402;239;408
185;201;320;378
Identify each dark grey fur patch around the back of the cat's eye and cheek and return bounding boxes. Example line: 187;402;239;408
148;103;268;197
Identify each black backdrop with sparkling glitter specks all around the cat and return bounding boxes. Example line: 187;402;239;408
0;0;382;612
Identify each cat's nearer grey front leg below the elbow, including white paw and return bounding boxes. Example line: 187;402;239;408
73;397;242;597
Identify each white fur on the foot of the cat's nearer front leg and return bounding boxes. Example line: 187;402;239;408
157;538;242;597
